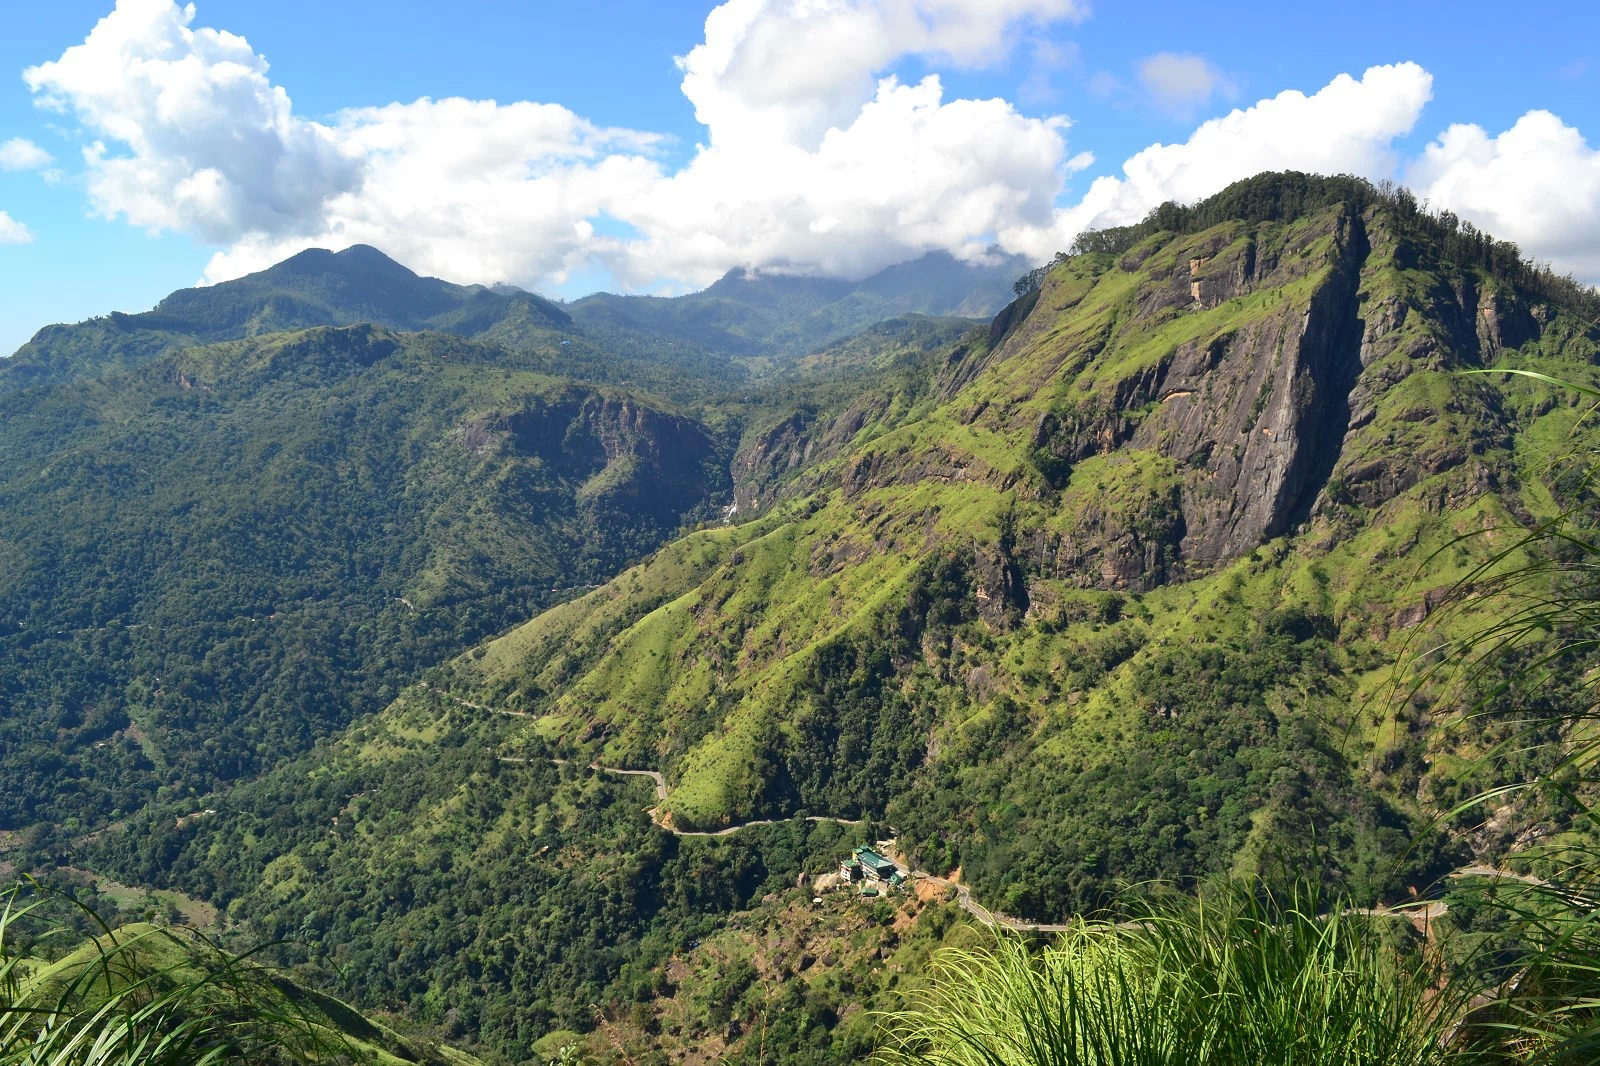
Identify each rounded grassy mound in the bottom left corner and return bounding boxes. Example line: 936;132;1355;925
0;890;342;1066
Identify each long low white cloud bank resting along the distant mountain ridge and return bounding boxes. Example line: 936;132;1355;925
208;77;1090;288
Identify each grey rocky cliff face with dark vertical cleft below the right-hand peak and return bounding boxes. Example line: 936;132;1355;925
960;202;1549;589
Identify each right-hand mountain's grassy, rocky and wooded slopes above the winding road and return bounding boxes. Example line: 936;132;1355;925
453;188;1597;917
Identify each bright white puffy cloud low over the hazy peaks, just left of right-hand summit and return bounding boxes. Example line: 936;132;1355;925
604;77;1088;283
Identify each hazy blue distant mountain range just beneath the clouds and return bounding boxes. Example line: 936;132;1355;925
0;245;1027;400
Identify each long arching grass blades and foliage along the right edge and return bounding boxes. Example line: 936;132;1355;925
1429;370;1600;1066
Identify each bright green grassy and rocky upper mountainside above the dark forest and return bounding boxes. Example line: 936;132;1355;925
444;178;1595;870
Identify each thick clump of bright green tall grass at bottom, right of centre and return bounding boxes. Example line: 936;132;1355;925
888;884;1477;1066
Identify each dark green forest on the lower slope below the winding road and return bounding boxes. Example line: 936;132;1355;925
65;688;928;1063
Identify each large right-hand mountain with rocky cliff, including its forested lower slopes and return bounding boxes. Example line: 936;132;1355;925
86;174;1600;1063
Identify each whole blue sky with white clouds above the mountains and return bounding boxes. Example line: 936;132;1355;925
0;0;1600;352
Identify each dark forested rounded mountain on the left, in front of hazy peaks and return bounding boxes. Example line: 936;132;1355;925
0;325;726;831
